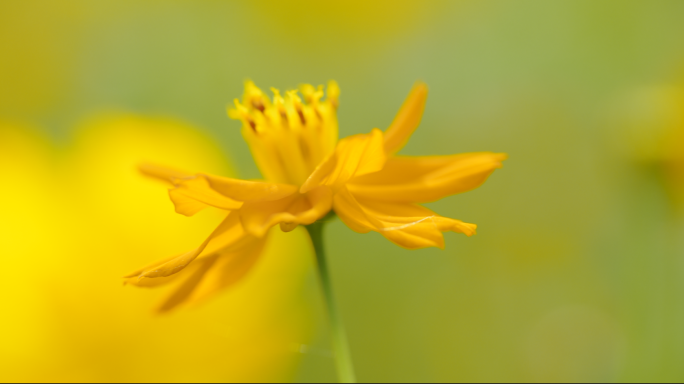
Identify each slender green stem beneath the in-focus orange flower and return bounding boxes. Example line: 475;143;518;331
306;221;356;383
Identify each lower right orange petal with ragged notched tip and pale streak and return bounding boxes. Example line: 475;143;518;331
333;188;476;249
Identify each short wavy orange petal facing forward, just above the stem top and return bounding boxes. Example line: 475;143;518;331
239;186;332;237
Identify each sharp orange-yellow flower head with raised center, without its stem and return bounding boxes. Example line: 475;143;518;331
126;82;506;309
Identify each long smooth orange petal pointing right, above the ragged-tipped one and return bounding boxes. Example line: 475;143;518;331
348;152;506;203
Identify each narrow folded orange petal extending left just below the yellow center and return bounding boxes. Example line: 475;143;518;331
203;174;298;202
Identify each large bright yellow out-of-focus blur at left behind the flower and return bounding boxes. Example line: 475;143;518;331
0;116;310;382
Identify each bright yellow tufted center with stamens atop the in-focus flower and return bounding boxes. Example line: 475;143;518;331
228;81;339;185
